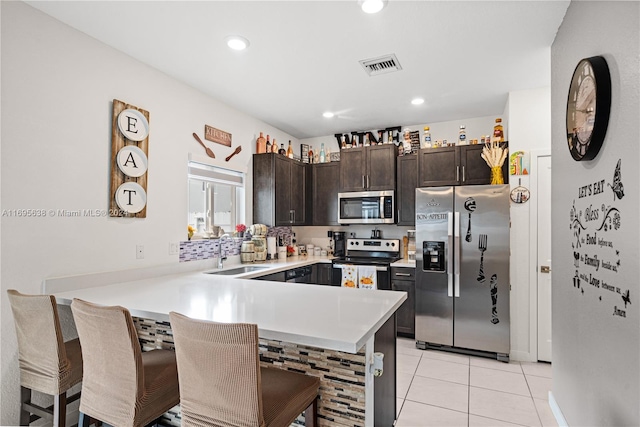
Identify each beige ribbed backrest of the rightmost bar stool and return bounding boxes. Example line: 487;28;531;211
170;312;265;427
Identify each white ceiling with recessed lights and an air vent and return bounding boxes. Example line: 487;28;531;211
27;0;569;139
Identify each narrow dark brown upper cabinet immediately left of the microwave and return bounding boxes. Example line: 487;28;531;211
311;162;340;225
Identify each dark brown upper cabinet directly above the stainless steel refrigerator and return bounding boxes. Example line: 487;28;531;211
418;144;509;187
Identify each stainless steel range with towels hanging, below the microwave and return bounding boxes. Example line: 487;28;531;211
333;239;401;290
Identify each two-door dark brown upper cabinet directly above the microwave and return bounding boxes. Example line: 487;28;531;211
340;144;397;191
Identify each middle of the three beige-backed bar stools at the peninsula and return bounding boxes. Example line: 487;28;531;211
71;299;180;427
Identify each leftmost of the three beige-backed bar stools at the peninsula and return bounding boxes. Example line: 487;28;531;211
7;289;82;427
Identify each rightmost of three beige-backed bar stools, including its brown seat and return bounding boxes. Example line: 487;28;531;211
169;312;320;427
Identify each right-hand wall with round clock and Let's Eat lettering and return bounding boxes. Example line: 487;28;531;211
551;1;640;426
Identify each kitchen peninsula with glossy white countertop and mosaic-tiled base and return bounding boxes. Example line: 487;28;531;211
45;260;406;426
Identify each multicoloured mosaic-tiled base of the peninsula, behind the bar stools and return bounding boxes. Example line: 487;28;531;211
134;317;366;427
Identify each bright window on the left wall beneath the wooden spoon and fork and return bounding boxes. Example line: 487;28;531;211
188;161;245;235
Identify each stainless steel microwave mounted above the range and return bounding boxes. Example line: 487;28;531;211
338;190;395;224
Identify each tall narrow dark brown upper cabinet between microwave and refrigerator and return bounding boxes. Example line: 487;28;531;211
396;155;418;225
